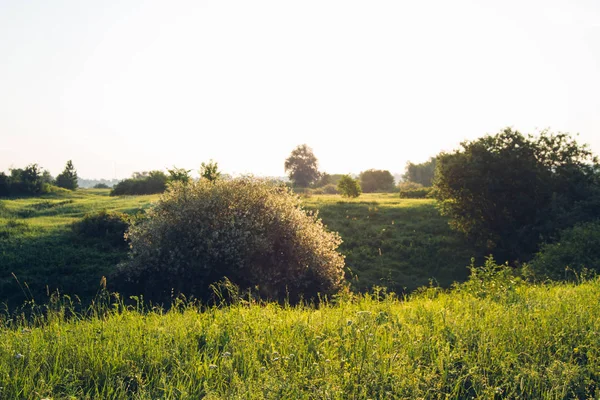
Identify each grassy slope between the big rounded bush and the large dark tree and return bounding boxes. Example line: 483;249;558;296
304;193;480;293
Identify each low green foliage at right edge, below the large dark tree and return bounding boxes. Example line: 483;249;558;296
529;221;600;279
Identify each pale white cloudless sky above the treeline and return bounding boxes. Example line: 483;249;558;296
0;0;600;178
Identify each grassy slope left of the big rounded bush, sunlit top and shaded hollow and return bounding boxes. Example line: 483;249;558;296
0;190;158;306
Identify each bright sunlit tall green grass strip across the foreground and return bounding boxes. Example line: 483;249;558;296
0;280;600;399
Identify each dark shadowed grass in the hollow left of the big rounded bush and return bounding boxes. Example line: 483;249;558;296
0;225;127;307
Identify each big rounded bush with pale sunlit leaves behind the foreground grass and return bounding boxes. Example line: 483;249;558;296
119;178;344;301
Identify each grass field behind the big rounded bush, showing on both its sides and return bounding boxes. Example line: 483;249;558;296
0;189;475;307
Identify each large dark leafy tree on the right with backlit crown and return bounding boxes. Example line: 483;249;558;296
433;128;600;260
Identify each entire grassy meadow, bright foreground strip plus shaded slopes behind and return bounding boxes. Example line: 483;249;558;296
0;190;600;399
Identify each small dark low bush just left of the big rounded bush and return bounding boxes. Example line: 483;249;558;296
71;210;130;246
